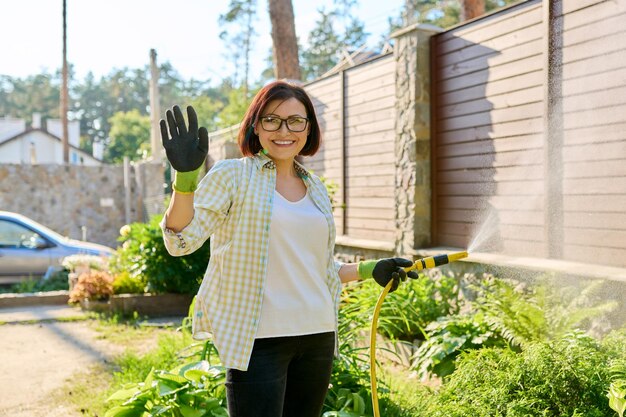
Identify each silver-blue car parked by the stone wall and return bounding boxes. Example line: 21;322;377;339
0;211;114;284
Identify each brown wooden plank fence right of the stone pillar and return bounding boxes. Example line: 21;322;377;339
431;0;626;266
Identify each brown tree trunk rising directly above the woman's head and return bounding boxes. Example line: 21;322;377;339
268;0;301;80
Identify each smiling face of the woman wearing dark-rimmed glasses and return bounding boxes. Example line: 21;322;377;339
254;98;310;161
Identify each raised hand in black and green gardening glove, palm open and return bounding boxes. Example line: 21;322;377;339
159;106;209;193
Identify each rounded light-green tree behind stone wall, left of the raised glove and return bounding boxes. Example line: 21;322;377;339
104;109;150;163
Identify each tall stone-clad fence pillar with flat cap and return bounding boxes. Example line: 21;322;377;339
391;24;441;256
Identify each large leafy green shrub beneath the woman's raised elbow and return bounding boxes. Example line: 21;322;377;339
111;215;210;294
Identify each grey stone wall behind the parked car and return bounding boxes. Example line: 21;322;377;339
0;163;163;247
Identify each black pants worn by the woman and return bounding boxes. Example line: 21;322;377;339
226;332;335;417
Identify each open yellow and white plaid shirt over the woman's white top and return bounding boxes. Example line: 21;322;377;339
161;153;341;371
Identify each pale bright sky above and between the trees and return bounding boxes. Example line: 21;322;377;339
0;0;404;83
